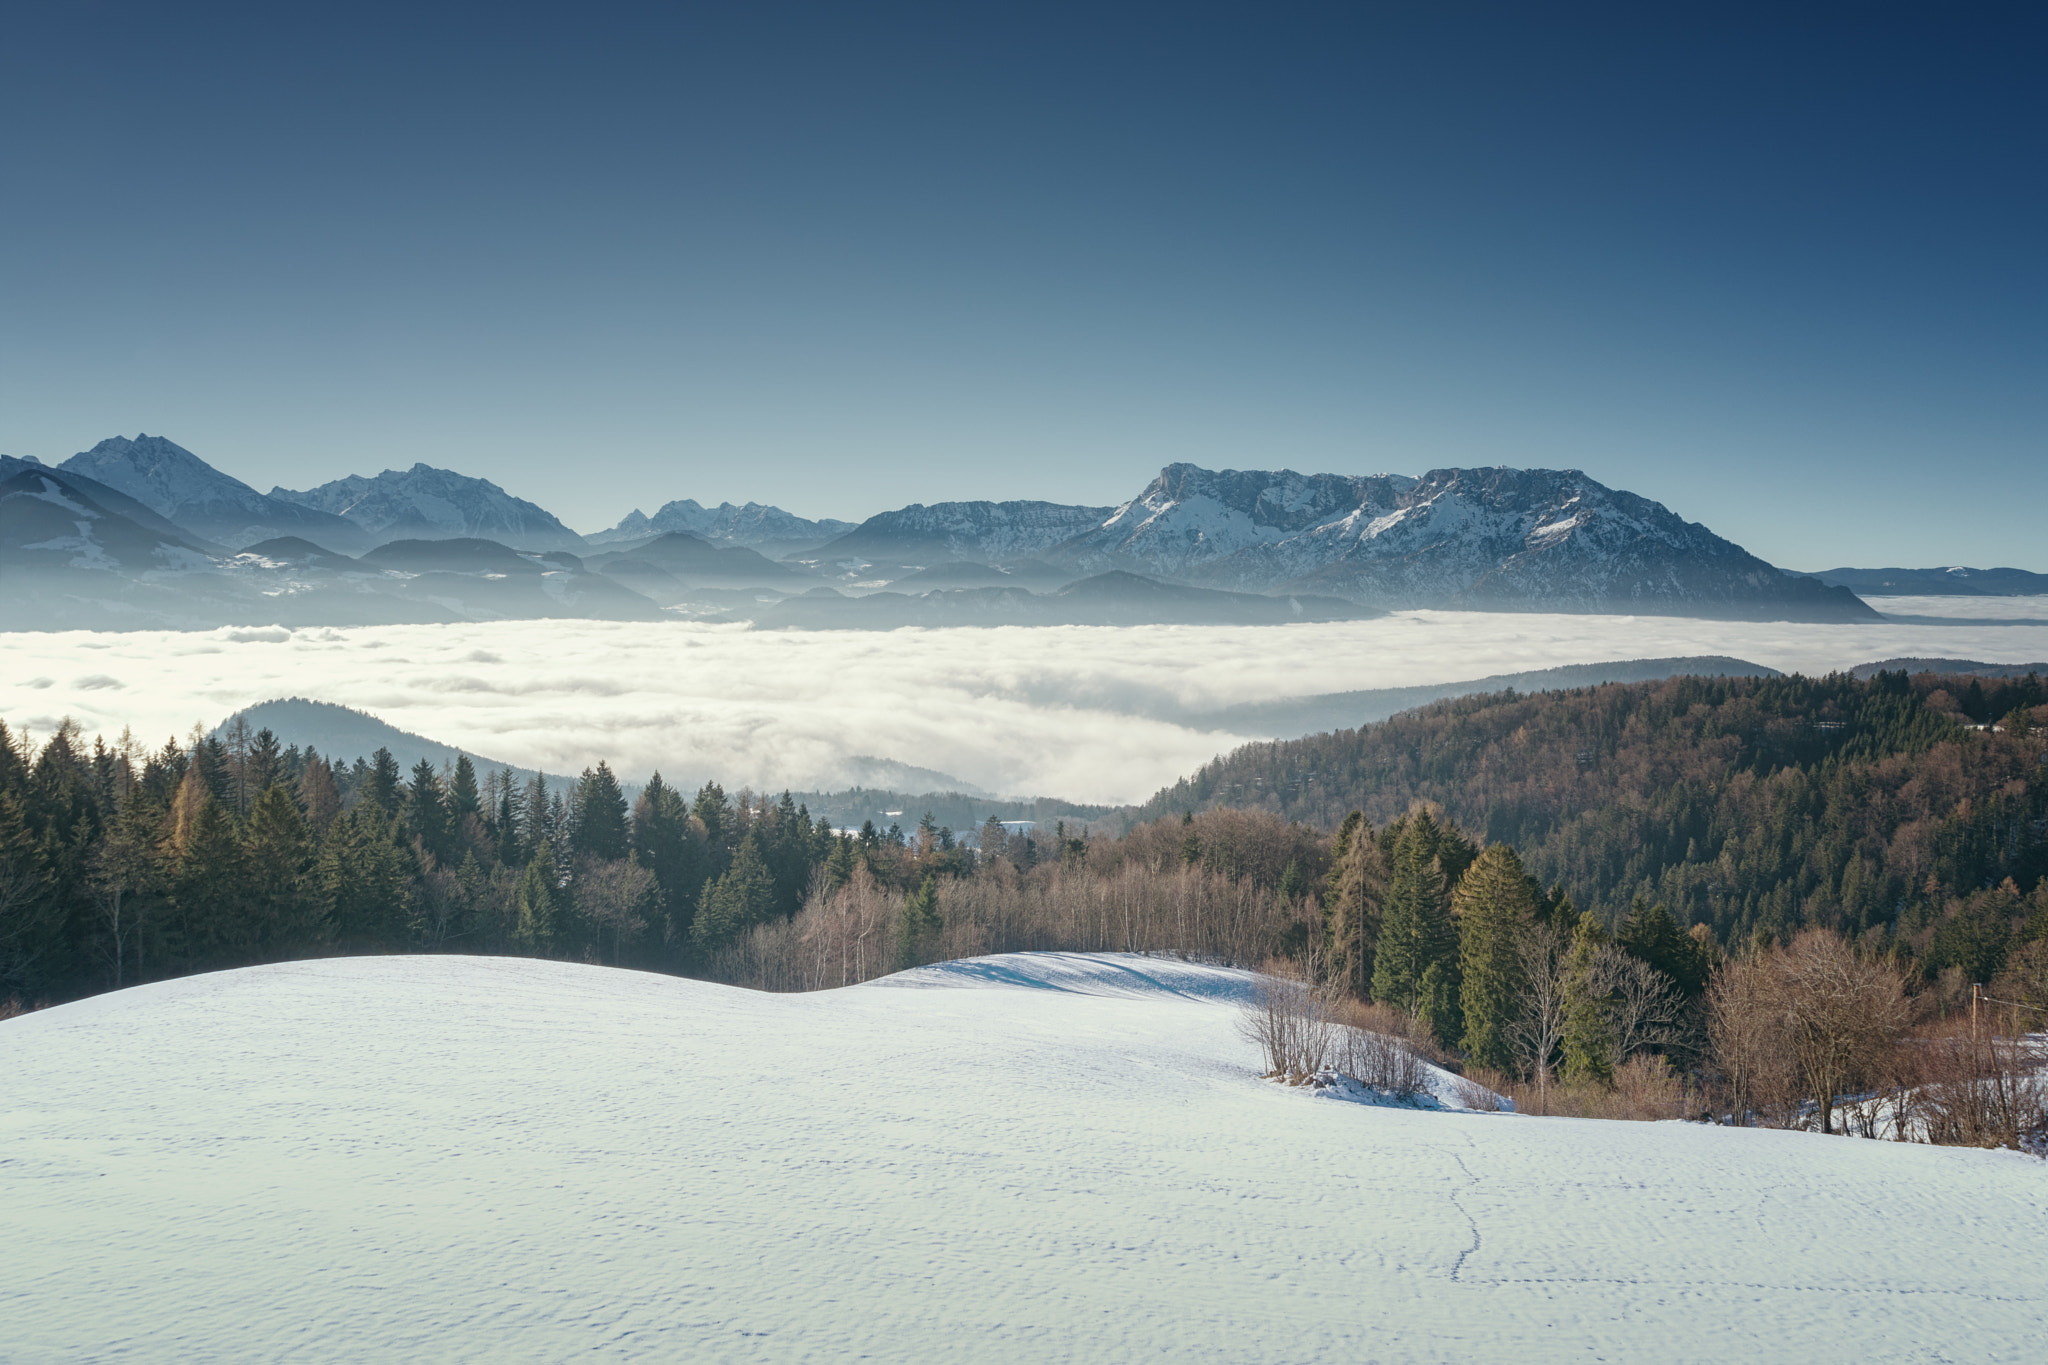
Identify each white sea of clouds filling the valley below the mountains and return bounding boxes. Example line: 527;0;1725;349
0;598;2048;802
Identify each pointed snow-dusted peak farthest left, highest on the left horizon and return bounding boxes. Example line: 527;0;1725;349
59;434;373;553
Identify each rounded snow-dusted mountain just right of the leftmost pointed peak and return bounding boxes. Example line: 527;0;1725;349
270;465;586;551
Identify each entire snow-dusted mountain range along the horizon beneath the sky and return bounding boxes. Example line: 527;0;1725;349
8;436;1908;620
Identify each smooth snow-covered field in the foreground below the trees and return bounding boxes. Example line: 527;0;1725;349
0;956;2048;1363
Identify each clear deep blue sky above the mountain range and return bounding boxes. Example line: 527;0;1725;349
0;0;2048;569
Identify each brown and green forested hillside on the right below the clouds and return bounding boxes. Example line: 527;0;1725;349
1137;673;2048;949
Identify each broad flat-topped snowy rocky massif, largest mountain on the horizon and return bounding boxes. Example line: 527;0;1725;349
1047;465;1876;620
